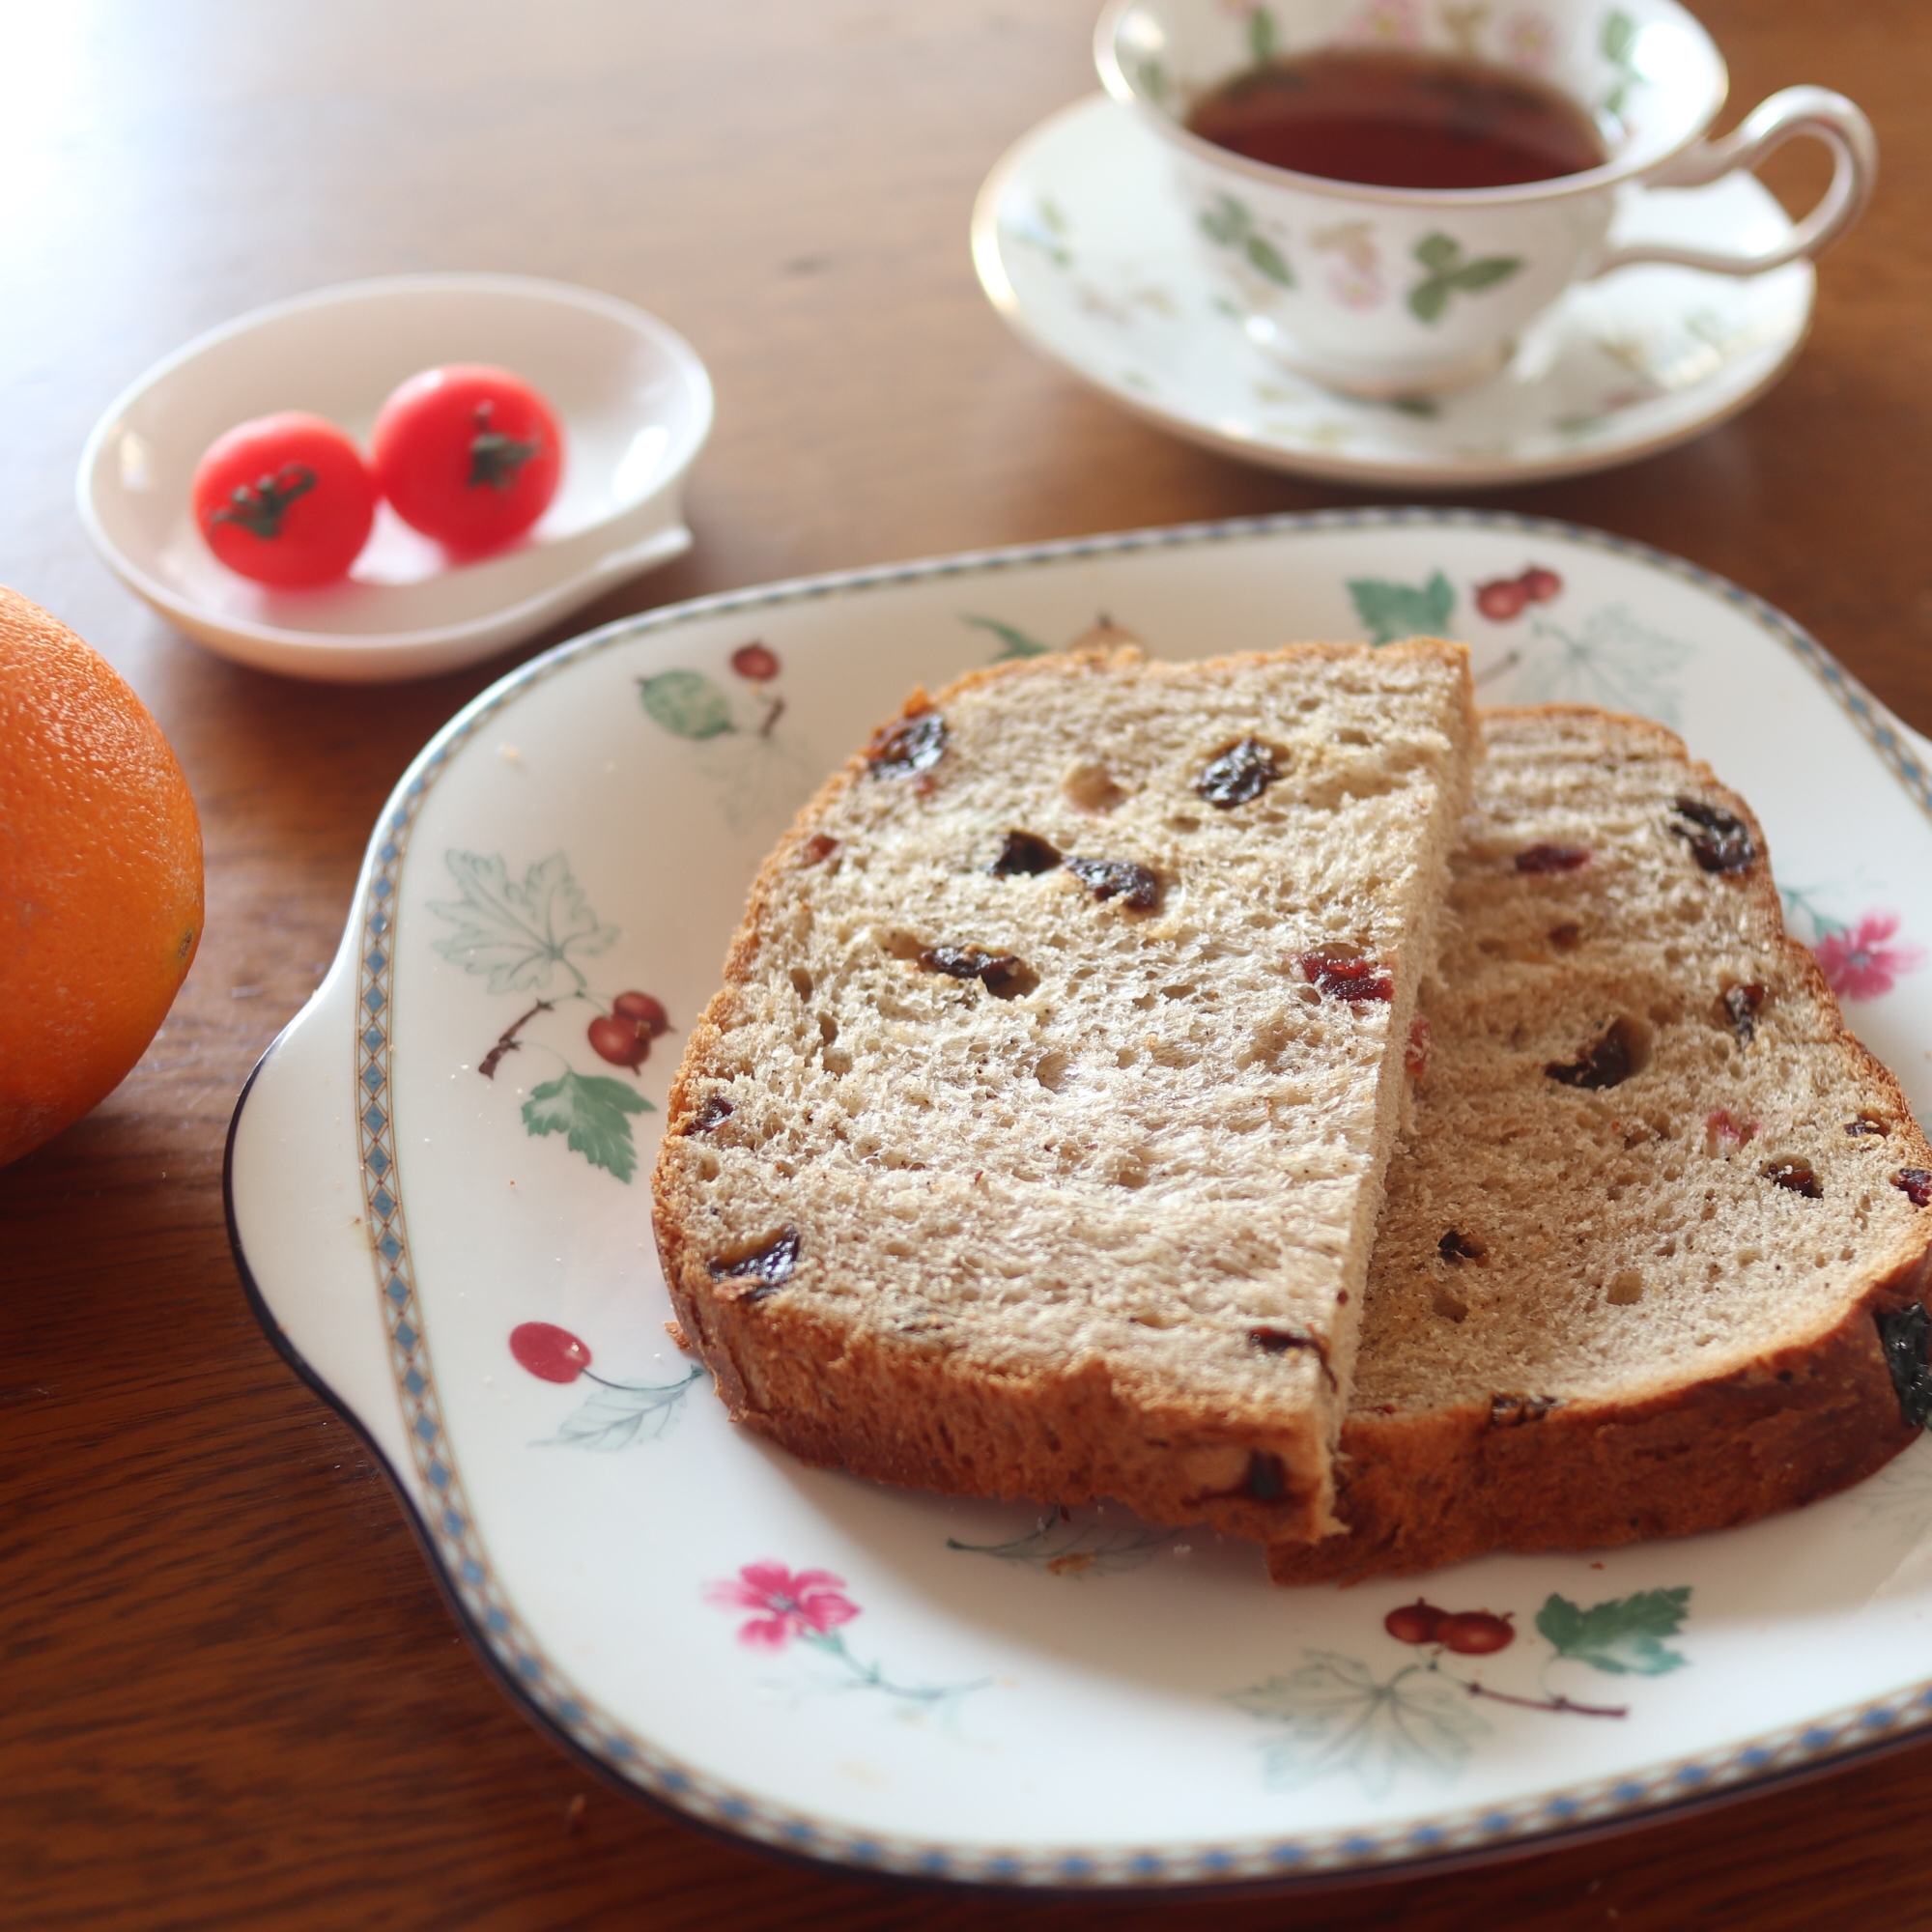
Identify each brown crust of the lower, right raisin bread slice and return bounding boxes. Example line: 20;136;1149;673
1267;705;1932;1584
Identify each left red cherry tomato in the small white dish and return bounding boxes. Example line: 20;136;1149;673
193;410;375;589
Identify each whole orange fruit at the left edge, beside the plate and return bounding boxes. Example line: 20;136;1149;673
0;587;201;1165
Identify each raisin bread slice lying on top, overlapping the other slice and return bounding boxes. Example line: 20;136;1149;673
655;639;1476;1540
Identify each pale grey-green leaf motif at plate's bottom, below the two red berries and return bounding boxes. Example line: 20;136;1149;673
1227;1650;1490;1797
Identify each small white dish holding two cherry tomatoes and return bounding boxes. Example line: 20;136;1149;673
77;274;711;684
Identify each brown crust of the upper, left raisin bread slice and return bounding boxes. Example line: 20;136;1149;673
653;639;1474;1542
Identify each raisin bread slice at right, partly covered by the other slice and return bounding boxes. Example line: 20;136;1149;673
1269;709;1932;1582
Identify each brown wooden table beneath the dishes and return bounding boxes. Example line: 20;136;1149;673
14;0;1932;1932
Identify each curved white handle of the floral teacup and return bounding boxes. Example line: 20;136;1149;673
1592;87;1878;274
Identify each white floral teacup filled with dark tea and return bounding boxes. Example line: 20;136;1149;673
1094;0;1878;396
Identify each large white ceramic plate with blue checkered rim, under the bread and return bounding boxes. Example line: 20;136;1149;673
228;510;1932;1888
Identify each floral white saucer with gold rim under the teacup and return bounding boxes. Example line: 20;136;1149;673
972;95;1816;487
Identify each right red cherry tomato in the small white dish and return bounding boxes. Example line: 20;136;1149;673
371;363;564;553
